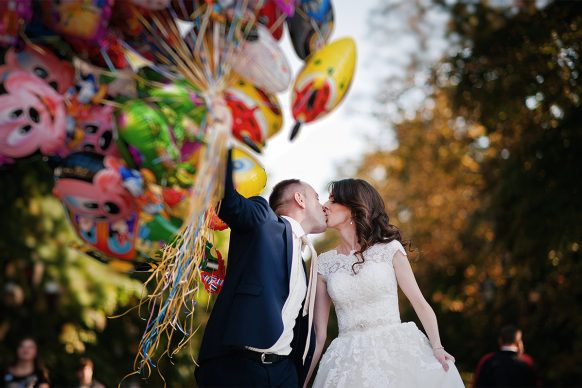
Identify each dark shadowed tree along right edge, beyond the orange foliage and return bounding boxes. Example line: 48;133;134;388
442;1;582;385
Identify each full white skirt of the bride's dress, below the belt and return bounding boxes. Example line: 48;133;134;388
313;322;464;388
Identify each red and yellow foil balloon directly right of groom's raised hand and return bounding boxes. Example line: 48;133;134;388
225;79;283;152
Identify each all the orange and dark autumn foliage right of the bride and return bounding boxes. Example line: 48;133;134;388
360;1;582;385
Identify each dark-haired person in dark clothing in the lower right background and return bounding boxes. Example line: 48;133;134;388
473;325;537;388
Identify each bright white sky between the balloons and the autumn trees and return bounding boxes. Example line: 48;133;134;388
259;0;393;201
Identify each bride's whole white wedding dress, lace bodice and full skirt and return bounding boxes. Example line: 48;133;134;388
313;241;464;388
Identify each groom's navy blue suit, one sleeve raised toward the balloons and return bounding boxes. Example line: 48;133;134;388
196;153;315;386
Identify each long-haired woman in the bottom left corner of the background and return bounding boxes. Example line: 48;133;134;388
2;337;49;388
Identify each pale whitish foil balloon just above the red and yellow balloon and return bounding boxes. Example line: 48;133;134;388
233;25;291;93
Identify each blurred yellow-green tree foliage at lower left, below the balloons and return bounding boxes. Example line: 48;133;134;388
0;159;213;386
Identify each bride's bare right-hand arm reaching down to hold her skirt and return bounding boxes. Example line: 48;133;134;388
392;251;455;370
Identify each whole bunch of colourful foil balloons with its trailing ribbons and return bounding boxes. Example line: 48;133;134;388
0;0;356;370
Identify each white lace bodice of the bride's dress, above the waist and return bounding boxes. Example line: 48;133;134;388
318;240;406;336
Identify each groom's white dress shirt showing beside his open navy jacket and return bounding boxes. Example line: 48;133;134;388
248;216;307;356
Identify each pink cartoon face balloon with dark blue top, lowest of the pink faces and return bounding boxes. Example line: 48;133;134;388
53;152;140;222
